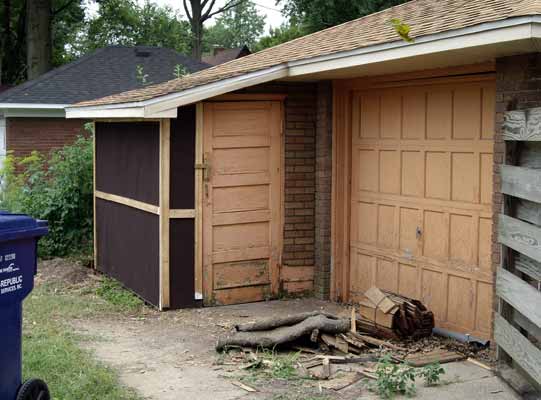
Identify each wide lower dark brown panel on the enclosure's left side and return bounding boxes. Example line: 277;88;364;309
96;199;159;306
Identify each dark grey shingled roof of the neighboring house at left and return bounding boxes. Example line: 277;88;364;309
0;46;209;108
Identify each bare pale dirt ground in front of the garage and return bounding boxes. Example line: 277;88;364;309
38;262;519;400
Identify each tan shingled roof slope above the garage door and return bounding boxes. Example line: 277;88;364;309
73;0;541;106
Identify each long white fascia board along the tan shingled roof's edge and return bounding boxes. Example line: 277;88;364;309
66;15;541;118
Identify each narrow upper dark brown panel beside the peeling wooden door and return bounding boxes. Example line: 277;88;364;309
170;105;195;209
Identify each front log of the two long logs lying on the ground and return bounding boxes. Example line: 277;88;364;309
216;315;350;351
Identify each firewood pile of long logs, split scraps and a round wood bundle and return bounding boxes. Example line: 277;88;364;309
216;287;434;355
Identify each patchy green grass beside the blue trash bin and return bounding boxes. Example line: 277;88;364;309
23;270;140;400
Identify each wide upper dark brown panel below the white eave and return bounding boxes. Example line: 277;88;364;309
96;122;160;205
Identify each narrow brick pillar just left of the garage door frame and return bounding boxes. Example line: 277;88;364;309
314;82;333;299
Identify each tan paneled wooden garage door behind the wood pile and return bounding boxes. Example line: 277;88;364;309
349;78;495;337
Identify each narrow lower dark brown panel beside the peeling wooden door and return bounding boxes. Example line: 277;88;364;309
169;219;200;309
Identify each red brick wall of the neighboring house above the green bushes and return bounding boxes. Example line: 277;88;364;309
6;118;86;157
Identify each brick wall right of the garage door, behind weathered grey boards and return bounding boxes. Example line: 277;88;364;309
492;53;541;282
